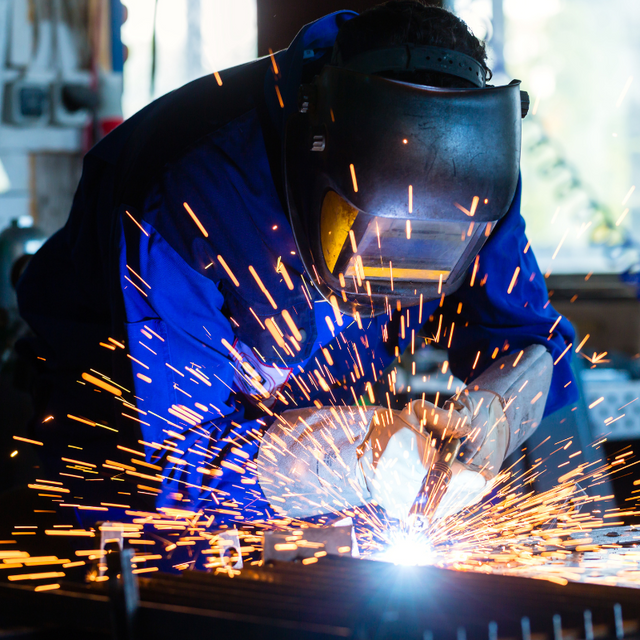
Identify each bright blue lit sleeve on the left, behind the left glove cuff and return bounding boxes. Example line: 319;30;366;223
120;218;270;523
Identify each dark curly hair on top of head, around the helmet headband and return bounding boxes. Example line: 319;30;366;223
333;0;491;88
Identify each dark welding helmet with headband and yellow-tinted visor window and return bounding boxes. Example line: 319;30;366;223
285;45;528;315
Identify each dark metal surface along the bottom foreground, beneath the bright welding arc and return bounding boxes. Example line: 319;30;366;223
0;555;640;640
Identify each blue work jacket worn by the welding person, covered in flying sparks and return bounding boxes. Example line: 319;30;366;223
18;12;577;522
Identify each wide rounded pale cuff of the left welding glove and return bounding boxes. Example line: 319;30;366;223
257;407;375;518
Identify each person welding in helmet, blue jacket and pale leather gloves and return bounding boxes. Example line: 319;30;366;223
18;0;576;523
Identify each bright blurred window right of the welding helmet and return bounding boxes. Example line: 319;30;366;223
449;0;640;274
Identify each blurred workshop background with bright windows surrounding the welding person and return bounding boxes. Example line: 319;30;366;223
0;0;640;506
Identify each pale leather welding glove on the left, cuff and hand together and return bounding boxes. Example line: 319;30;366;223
256;403;469;518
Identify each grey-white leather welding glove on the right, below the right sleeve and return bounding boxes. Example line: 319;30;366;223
435;345;553;519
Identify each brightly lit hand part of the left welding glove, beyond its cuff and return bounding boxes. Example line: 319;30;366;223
358;401;470;519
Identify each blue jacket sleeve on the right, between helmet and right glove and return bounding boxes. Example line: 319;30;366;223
436;178;578;416
